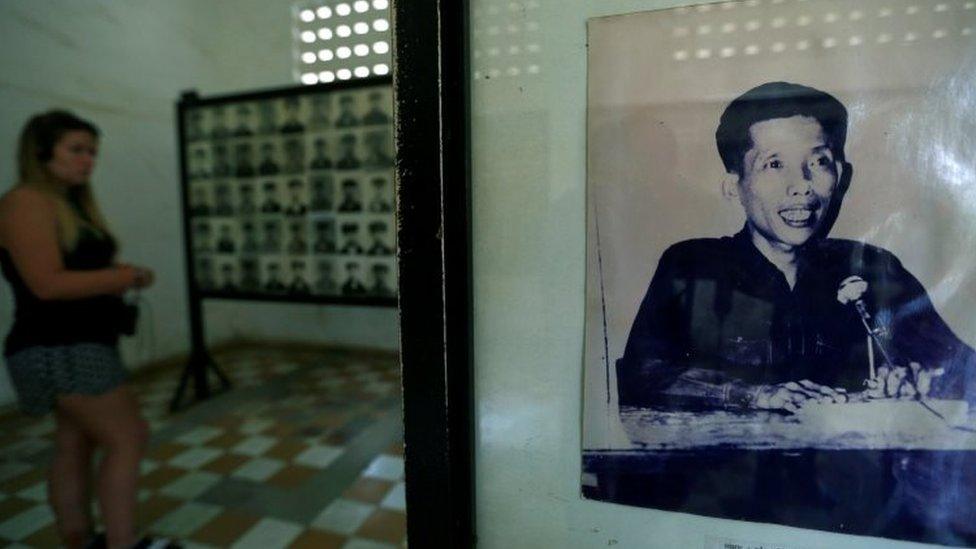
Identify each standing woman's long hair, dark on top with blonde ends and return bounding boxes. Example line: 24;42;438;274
17;110;115;252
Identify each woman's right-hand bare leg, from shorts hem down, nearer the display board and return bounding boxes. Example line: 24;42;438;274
58;386;149;549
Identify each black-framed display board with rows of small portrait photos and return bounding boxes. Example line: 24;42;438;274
179;78;396;306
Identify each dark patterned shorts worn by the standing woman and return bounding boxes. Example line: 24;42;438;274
7;343;127;415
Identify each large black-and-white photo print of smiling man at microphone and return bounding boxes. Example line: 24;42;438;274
581;0;976;545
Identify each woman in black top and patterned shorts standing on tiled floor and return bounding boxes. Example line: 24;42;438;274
0;111;159;549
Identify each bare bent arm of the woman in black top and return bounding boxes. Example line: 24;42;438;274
0;188;138;300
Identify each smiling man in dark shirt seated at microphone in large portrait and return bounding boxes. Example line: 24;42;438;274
617;82;976;412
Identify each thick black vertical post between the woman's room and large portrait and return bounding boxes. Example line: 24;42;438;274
393;0;475;548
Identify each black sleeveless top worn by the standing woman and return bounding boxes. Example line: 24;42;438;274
0;220;122;356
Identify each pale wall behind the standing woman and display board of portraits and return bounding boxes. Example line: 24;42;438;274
0;0;397;404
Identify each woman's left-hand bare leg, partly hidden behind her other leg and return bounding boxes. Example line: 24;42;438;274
47;410;94;549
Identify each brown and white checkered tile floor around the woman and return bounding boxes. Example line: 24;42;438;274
0;346;406;549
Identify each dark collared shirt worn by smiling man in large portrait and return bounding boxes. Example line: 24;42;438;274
617;229;976;408
